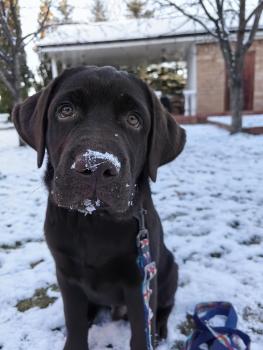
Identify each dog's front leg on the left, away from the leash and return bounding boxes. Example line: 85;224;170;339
57;271;89;350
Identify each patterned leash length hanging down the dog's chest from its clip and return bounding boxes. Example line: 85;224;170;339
137;208;157;350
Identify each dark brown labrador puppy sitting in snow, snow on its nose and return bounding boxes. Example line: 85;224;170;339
13;67;185;350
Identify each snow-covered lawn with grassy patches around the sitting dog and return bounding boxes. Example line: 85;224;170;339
0;125;263;350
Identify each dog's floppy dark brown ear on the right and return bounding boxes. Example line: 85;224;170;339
148;89;186;182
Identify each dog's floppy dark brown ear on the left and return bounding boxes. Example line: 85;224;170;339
12;79;56;168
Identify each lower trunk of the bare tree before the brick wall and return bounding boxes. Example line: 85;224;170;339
230;73;243;134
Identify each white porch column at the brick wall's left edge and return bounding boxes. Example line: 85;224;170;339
184;43;197;115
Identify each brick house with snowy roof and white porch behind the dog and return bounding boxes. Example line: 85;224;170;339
37;17;263;115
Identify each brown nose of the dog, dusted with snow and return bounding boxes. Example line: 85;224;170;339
72;155;119;181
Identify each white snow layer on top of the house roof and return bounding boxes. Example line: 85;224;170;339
37;16;209;48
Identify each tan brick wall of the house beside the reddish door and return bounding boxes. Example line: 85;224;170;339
197;40;263;114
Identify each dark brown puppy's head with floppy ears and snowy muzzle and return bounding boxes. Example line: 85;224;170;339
13;67;185;213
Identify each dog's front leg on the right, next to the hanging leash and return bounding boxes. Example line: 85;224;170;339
125;285;154;350
